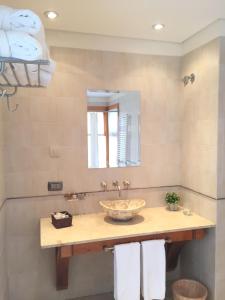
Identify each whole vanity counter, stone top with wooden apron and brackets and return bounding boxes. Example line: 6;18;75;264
41;207;215;290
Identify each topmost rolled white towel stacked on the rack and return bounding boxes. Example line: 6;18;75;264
0;5;42;35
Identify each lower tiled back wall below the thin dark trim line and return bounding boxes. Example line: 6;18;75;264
6;188;179;300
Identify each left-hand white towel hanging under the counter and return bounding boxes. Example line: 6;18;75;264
114;243;140;300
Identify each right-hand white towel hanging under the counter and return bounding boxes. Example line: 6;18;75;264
141;240;166;300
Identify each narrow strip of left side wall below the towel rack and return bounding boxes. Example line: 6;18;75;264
0;102;7;300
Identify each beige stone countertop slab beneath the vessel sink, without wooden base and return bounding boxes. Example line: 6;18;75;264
40;207;215;248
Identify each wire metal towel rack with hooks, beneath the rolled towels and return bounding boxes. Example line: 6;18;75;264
0;56;50;112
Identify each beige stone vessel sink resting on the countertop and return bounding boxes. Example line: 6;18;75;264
99;199;146;221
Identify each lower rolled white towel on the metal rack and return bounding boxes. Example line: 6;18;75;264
0;30;43;61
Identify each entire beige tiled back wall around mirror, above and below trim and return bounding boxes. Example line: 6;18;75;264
4;48;182;300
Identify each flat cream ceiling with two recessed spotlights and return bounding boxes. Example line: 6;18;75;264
1;0;225;43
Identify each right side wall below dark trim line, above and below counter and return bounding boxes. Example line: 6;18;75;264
180;189;215;300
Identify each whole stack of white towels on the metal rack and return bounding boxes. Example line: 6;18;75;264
0;5;55;86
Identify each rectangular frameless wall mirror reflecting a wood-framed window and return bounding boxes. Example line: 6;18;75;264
87;90;140;168
